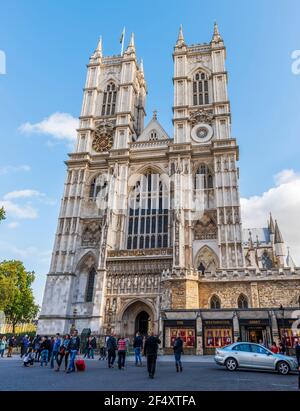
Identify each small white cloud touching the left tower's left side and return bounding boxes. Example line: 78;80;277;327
19;113;78;143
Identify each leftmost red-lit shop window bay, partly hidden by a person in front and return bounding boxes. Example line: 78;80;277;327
164;320;196;354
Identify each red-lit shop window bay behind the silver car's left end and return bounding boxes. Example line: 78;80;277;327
202;319;233;355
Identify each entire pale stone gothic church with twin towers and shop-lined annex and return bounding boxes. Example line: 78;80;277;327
38;24;300;354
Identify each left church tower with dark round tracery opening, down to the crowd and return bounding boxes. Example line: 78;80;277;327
39;34;147;334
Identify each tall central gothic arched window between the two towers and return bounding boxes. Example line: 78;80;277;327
127;171;169;250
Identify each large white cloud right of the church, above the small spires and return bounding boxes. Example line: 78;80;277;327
241;170;300;264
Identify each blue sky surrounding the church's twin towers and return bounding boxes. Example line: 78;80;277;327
0;0;300;302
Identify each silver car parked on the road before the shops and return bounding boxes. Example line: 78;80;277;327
215;342;298;375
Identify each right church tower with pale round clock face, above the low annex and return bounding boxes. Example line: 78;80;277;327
173;23;244;271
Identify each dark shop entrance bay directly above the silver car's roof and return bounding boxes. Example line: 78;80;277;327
239;318;272;347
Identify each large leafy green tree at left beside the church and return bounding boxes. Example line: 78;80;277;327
0;260;39;332
